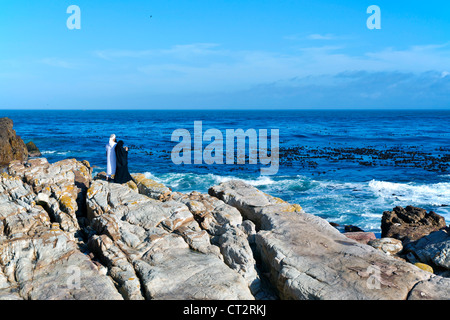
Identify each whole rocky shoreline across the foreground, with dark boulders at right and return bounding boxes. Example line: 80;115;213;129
0;118;450;300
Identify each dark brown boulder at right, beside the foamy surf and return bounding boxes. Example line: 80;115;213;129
381;206;446;243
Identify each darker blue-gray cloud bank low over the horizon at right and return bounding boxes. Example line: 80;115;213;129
228;71;450;109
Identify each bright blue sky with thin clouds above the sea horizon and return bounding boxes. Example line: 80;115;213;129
0;0;450;109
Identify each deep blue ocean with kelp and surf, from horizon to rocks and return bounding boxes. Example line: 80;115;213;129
0;110;450;235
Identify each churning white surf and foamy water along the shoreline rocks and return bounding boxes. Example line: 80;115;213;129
141;172;450;232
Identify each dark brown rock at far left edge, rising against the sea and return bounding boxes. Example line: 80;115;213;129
0;118;28;165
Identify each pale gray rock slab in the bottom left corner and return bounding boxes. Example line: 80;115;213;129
0;228;121;300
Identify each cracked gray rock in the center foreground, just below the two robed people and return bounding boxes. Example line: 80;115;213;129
87;180;254;300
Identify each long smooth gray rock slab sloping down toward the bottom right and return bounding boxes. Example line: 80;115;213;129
209;181;450;300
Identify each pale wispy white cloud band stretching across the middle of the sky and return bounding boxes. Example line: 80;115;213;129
86;43;450;96
